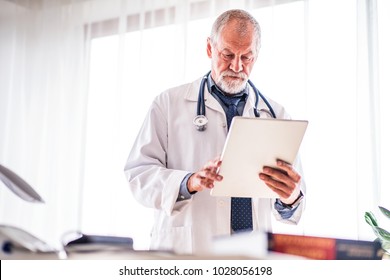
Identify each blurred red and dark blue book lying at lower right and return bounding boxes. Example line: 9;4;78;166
268;233;384;260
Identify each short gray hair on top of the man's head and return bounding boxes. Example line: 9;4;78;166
210;9;261;53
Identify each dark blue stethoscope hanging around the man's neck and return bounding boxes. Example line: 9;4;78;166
193;71;276;131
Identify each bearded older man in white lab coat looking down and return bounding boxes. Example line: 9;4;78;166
125;10;305;254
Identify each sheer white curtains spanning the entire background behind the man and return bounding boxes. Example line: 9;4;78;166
0;0;390;249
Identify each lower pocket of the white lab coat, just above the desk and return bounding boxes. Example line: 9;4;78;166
150;226;192;254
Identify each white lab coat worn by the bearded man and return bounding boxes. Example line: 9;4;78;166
125;75;304;254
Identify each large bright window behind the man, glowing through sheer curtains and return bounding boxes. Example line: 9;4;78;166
82;0;390;248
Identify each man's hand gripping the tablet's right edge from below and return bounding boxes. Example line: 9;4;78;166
259;160;301;204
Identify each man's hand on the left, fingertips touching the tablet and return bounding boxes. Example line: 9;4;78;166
187;157;223;193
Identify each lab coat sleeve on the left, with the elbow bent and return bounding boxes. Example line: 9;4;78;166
125;98;191;215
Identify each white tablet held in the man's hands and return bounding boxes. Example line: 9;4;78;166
210;117;308;198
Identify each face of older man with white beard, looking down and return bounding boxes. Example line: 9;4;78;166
207;21;257;94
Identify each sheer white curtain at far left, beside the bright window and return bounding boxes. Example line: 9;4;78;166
0;1;87;246
